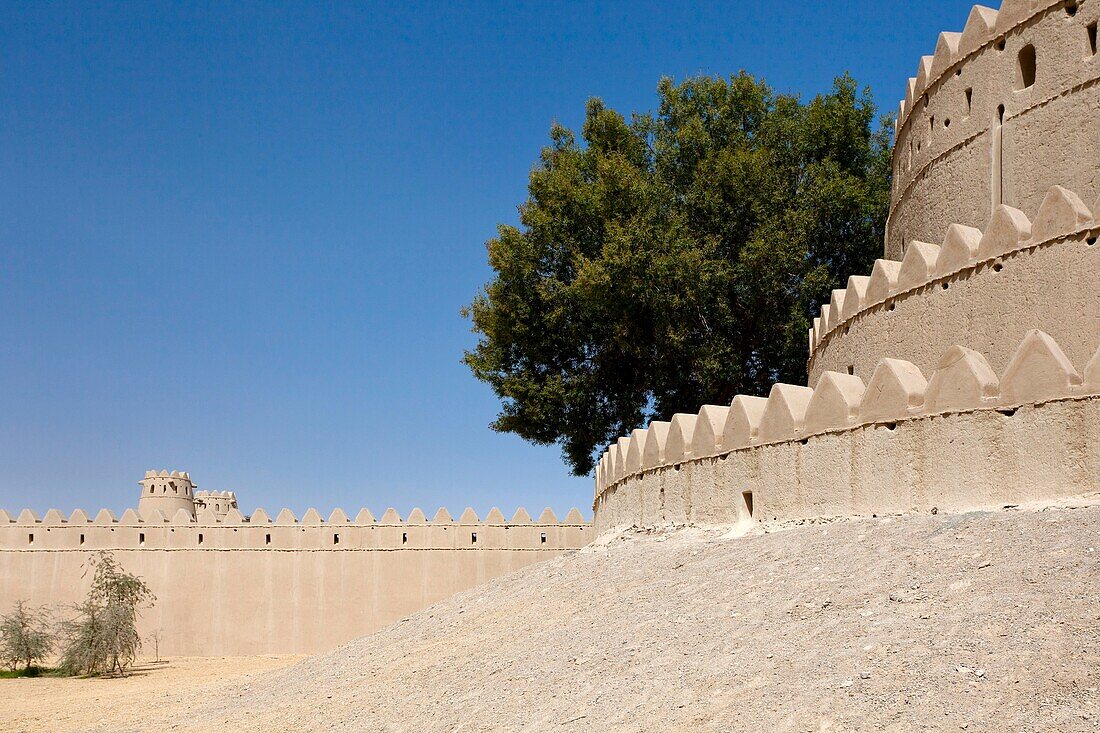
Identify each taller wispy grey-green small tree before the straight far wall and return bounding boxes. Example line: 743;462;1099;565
62;551;156;675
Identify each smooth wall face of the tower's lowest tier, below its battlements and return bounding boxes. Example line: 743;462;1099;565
595;397;1100;534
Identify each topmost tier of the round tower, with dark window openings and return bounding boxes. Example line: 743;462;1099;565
886;0;1100;260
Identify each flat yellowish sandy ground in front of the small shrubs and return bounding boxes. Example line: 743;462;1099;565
0;655;304;733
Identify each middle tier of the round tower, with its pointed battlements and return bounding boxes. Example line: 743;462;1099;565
807;186;1100;381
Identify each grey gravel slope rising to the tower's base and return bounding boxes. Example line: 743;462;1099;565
113;505;1100;733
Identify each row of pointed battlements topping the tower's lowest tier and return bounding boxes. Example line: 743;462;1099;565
596;330;1100;503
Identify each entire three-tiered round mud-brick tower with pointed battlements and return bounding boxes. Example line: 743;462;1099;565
593;0;1100;533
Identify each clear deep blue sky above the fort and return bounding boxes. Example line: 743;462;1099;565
0;0;970;516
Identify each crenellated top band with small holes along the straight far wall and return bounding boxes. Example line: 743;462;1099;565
0;506;591;551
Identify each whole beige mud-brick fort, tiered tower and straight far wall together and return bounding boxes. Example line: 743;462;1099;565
0;0;1100;655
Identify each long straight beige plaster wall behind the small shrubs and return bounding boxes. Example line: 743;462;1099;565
0;510;592;656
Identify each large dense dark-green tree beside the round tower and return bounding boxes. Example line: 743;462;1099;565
463;73;890;475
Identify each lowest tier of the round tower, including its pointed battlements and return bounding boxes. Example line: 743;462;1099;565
594;330;1100;532
